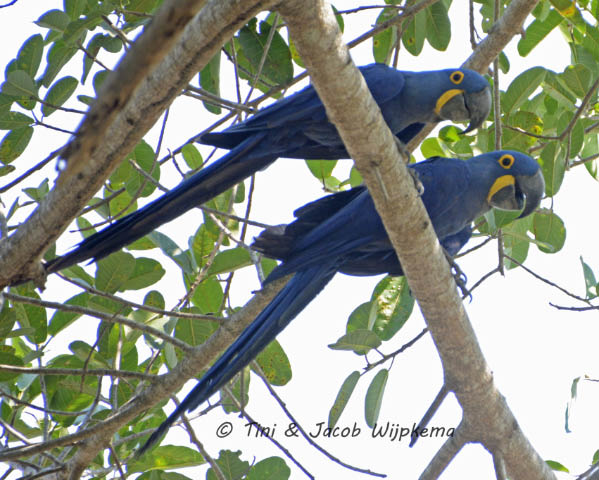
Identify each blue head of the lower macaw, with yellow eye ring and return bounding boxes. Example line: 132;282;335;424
469;150;545;218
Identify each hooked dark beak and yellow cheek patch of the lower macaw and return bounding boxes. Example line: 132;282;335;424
488;169;545;218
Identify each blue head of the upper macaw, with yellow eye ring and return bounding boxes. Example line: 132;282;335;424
430;68;491;133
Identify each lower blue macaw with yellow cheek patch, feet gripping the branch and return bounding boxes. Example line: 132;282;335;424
141;150;545;452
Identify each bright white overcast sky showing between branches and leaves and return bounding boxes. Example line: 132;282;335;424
0;0;599;480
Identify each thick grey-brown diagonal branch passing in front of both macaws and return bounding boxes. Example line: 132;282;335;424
279;0;554;480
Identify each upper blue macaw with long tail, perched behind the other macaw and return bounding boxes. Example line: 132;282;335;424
46;63;491;273
